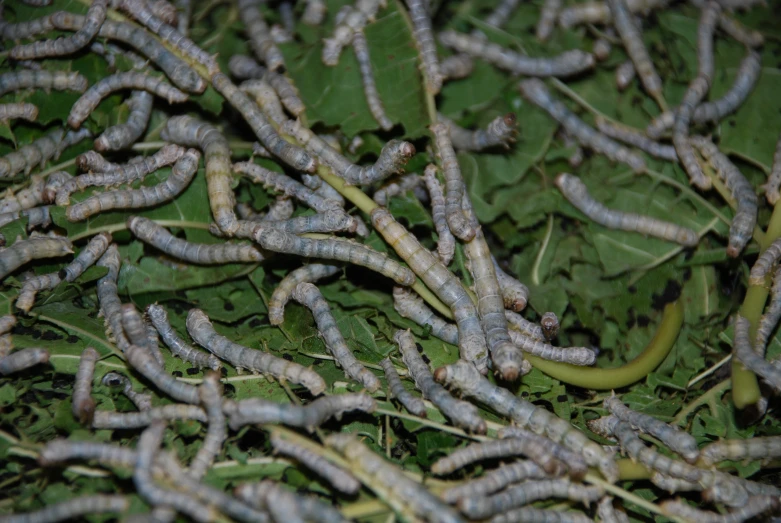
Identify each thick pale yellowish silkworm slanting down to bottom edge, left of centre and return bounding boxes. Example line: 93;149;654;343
325;434;464;523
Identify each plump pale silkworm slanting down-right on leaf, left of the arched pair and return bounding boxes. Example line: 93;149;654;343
187;309;325;395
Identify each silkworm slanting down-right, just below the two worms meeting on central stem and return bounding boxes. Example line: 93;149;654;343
393;330;486;434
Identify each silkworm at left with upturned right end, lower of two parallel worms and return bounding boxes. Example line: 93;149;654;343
65;149;201;222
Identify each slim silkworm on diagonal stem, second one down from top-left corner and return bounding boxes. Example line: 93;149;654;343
212;72;317;173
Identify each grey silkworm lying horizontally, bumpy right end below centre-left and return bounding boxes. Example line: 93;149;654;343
223;393;377;432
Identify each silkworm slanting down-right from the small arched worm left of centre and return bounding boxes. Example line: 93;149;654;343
292;282;380;392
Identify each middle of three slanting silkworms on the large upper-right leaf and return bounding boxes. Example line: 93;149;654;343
519;78;645;172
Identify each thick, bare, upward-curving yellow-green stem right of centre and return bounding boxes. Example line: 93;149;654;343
526;301;683;390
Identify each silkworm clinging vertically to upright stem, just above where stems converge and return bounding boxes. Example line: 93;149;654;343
430;122;477;242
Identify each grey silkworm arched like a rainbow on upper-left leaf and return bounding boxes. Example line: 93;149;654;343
68;71;188;129
